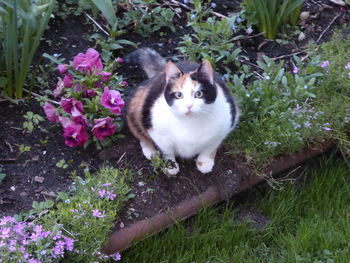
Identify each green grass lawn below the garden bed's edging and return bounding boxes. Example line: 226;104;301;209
123;158;350;263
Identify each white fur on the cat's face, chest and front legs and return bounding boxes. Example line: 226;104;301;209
148;80;236;174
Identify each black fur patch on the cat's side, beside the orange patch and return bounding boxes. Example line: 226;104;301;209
142;73;165;129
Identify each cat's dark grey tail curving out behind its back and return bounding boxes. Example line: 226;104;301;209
124;48;166;78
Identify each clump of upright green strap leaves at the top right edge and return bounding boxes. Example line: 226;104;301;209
243;0;304;39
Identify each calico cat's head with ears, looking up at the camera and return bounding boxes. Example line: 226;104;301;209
164;61;217;117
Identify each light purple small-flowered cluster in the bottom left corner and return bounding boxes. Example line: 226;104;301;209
0;216;74;263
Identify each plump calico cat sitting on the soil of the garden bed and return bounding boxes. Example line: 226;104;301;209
125;48;239;175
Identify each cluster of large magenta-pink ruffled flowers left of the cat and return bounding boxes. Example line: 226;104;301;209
43;48;127;150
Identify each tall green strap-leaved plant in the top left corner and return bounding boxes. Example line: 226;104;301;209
0;0;55;99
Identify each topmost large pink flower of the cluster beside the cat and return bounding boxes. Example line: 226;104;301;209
73;48;103;74
